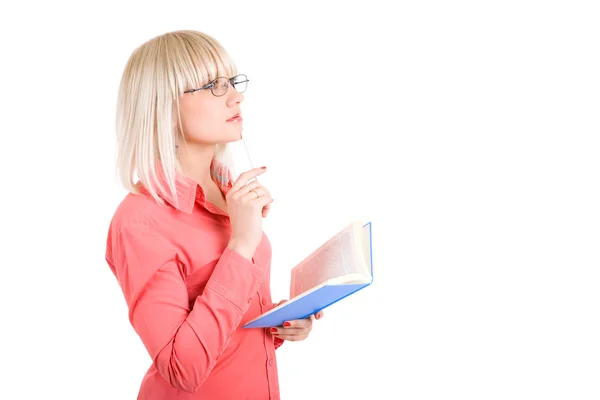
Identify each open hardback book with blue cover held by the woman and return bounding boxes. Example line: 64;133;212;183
244;220;373;328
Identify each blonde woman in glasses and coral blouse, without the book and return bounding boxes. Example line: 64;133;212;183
106;31;322;400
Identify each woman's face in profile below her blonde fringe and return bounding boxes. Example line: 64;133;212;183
179;76;244;145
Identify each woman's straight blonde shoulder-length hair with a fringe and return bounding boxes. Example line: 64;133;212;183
116;30;237;203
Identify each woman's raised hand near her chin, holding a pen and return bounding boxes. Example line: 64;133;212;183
225;167;273;260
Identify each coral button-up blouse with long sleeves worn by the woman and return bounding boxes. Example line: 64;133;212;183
106;161;282;400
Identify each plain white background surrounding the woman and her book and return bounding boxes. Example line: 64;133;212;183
0;0;600;400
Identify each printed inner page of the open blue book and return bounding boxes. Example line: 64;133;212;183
290;224;364;298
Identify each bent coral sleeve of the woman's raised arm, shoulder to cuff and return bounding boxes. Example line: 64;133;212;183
112;219;265;392
